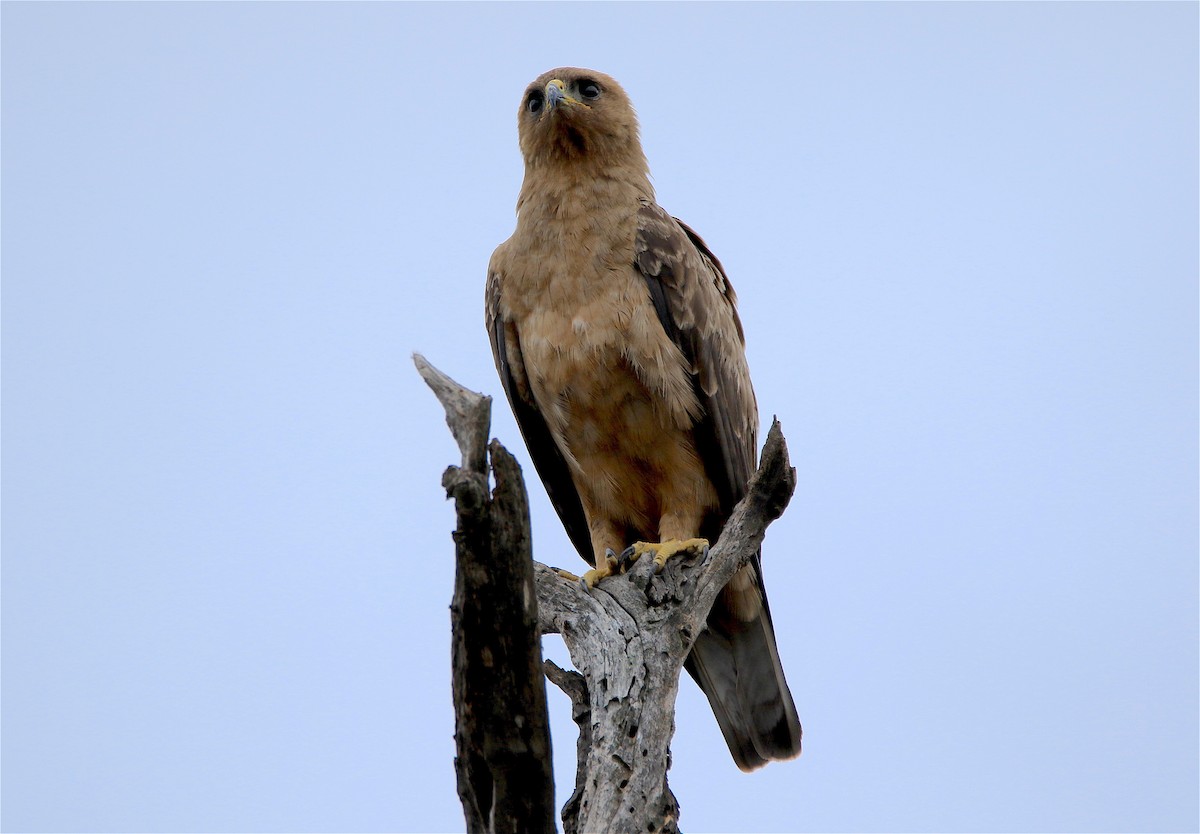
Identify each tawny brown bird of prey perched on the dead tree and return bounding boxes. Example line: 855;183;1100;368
486;68;800;770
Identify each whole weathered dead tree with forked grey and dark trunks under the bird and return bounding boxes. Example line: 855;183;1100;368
414;355;796;834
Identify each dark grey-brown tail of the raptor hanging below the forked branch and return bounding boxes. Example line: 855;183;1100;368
685;556;800;770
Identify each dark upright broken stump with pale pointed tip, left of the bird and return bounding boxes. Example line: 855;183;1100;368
413;355;554;834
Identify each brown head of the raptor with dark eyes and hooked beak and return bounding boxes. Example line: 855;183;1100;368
517;67;644;174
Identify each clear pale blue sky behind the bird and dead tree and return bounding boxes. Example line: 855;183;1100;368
0;2;1200;832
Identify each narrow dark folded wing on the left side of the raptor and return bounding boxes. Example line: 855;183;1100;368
486;272;594;563
